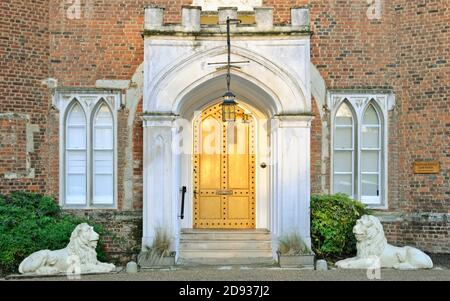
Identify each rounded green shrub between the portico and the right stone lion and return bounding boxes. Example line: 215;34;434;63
311;194;370;258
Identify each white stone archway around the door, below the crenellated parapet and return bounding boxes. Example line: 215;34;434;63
143;32;312;256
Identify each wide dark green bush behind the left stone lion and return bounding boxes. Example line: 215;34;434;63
0;192;106;274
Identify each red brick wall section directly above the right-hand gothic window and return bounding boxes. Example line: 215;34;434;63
311;0;396;89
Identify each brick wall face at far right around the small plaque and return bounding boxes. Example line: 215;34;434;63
394;0;450;213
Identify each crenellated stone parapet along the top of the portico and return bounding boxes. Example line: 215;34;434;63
144;5;310;34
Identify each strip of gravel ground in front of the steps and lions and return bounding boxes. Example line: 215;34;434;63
6;266;450;281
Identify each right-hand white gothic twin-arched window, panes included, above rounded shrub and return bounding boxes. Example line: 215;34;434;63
328;91;395;208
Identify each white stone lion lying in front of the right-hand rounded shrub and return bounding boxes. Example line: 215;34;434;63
336;215;433;270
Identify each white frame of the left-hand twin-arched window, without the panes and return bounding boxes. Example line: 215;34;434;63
52;90;122;209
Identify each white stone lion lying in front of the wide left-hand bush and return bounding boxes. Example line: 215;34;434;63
19;223;116;275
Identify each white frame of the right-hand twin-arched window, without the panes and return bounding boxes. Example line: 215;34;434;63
327;90;395;209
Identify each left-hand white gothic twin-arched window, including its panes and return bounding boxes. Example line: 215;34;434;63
54;93;120;208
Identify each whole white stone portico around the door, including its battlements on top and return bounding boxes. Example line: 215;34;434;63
143;7;312;262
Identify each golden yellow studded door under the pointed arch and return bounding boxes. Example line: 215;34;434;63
193;104;256;229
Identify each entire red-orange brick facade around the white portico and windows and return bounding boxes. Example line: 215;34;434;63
0;0;450;258
